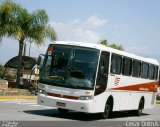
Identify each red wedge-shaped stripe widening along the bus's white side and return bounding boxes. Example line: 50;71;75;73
108;82;158;92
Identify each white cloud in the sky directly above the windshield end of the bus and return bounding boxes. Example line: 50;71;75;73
51;16;107;43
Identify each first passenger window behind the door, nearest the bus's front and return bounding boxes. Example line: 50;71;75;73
111;54;122;74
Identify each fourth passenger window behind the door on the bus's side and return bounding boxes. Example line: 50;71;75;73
141;63;149;79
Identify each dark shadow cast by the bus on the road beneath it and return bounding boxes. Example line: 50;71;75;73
24;109;149;121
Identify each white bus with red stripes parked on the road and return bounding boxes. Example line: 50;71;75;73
38;41;159;119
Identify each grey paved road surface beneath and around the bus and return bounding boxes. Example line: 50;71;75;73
0;100;160;127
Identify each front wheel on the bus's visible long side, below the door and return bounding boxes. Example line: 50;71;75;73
102;101;112;119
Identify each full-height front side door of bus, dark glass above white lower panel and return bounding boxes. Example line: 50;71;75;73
93;52;110;112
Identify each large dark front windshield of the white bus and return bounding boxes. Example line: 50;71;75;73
40;45;99;90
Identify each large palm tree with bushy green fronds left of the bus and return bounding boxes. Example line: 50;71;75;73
0;0;57;87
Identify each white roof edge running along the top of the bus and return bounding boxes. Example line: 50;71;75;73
51;41;159;66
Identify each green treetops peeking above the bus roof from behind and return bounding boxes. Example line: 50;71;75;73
100;39;124;51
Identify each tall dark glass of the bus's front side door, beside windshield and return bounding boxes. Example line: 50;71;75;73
95;51;110;95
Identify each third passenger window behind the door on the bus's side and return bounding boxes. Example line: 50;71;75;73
132;60;141;77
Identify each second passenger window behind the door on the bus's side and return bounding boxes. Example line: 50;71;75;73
122;57;132;76
